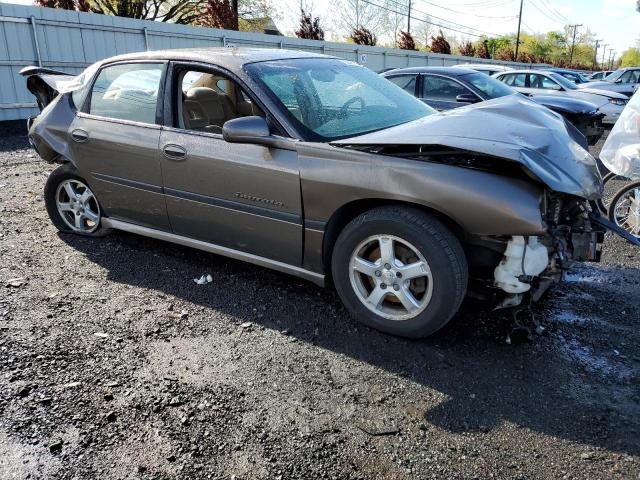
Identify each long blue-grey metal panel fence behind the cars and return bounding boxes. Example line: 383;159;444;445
0;3;552;121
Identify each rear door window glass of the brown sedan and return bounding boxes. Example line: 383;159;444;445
89;63;164;124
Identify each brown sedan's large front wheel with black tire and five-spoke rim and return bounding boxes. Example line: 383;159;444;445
331;206;468;338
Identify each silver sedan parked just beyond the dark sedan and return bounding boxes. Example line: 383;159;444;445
494;70;629;124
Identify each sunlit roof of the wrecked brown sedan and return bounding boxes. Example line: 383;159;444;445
97;47;335;69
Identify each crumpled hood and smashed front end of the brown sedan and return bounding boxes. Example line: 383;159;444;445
336;97;639;308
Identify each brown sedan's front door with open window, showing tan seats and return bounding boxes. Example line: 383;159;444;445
160;64;302;265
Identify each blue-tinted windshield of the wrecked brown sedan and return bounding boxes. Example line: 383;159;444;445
245;58;435;142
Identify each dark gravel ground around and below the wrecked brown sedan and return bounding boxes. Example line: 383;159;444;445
0;125;640;480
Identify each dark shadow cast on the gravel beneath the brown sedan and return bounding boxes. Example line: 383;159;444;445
61;233;640;455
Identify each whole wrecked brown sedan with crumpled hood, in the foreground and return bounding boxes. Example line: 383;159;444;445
23;48;639;337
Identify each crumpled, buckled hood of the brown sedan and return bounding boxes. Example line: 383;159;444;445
332;95;602;200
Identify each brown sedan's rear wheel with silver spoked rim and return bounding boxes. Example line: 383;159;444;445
44;163;110;237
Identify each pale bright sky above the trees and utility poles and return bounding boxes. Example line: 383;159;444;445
0;0;640;57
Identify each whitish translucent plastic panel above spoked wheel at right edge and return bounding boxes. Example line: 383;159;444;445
600;90;640;180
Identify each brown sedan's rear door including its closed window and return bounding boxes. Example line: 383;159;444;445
69;62;170;230
